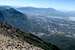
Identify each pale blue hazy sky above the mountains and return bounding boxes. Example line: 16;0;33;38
0;0;75;11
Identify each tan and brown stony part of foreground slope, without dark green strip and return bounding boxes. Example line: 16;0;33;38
0;24;44;50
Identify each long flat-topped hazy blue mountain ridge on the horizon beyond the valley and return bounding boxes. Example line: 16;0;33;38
17;7;66;16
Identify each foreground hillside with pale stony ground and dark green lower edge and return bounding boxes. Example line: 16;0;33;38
0;23;59;50
